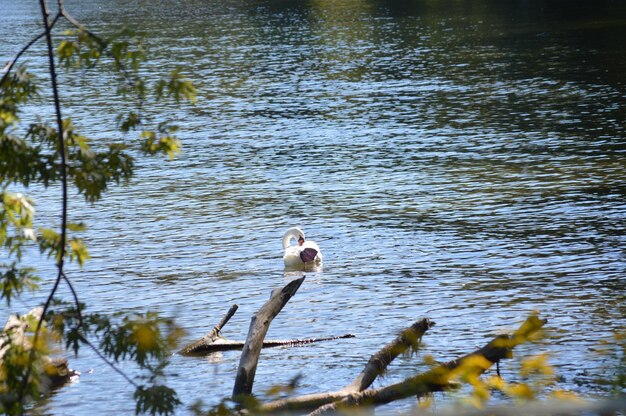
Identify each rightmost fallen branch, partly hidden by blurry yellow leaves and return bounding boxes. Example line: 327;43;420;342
311;315;547;416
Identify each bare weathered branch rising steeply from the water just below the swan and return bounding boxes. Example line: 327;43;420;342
233;277;304;400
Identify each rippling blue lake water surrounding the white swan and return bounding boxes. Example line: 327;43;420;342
0;0;626;415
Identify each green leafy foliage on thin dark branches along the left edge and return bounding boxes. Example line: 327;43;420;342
0;2;195;414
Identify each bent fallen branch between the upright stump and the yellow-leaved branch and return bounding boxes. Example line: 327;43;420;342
255;318;435;413
